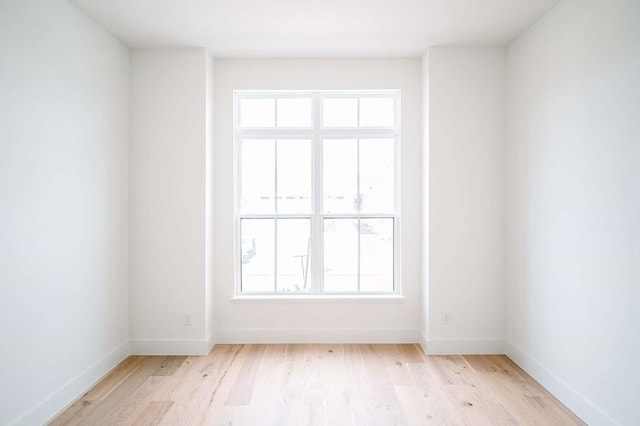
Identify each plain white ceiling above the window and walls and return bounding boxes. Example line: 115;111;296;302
70;0;559;57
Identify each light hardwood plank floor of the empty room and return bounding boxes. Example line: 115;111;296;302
51;344;584;426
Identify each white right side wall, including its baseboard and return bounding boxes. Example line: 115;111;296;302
507;0;640;425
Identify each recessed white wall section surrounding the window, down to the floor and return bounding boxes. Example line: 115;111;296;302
214;58;422;342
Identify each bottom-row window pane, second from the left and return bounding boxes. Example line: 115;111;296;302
276;219;311;292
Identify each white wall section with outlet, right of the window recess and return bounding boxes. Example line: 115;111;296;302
422;47;506;354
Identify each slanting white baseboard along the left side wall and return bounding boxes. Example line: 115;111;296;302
11;341;129;425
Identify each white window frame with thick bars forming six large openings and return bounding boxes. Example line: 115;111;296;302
233;90;402;297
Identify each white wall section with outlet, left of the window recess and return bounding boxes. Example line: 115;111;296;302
129;48;212;354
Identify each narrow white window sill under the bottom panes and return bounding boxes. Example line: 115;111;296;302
231;294;406;303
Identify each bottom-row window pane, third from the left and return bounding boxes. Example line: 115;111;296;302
324;219;358;293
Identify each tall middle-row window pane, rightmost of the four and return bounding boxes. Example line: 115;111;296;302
360;139;395;213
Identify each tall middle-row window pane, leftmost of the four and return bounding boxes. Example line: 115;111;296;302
240;139;275;213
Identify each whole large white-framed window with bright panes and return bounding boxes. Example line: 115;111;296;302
235;91;400;295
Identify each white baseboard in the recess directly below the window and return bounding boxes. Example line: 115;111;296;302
216;328;418;343
